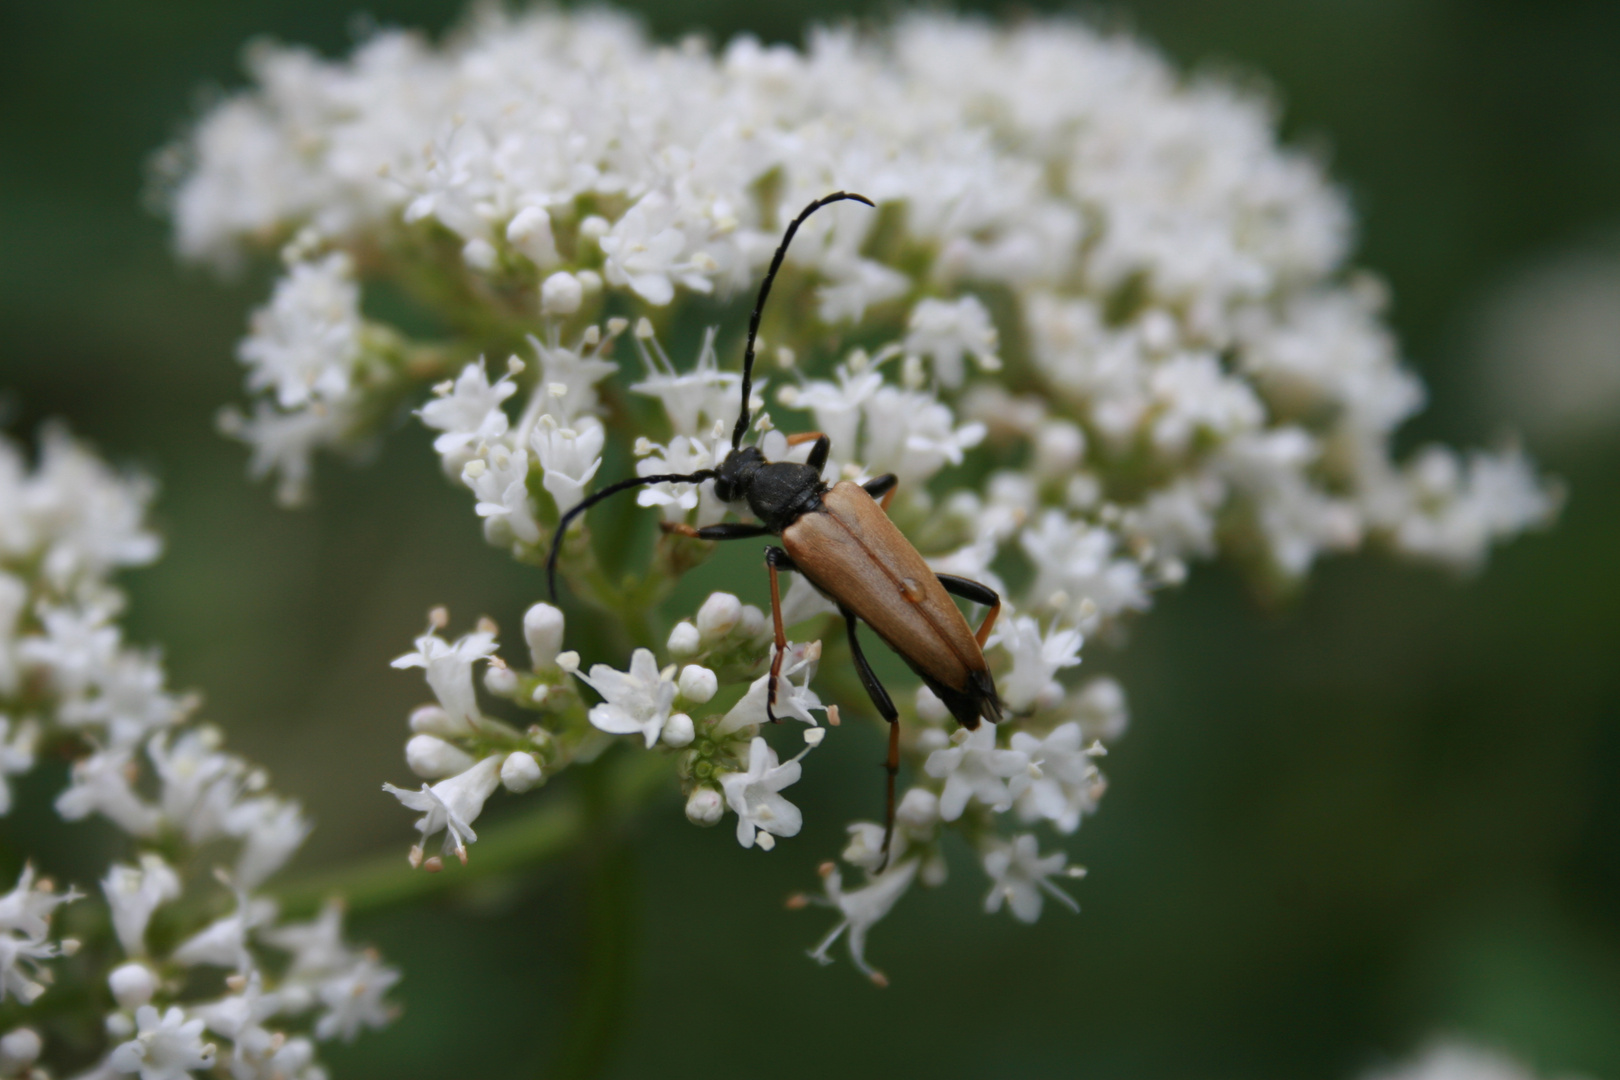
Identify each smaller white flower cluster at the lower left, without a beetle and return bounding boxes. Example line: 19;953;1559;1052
0;429;399;1080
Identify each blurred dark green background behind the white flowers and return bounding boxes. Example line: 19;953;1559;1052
0;0;1620;1080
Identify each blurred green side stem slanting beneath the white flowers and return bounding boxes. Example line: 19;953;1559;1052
277;751;669;916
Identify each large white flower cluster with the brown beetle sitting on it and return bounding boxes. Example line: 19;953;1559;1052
172;10;1558;978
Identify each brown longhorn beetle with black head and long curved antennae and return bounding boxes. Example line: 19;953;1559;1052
546;191;1001;870
